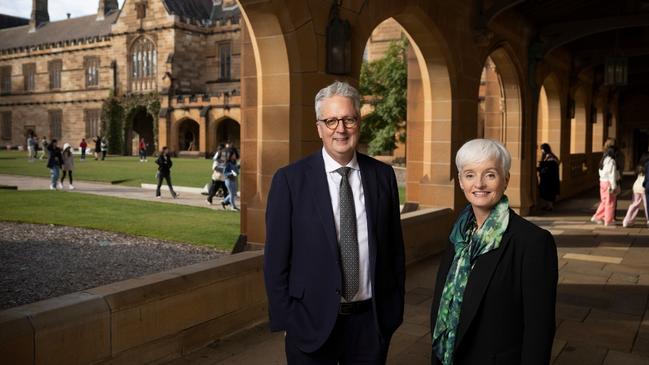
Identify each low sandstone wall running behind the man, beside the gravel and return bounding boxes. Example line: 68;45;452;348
0;209;452;365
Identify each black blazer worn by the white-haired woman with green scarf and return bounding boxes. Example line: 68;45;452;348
431;210;558;365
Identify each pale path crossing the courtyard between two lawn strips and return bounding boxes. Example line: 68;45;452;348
0;175;233;209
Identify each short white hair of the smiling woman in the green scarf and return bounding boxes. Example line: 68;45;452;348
455;138;512;176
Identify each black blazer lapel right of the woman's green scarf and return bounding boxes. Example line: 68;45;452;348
455;229;511;349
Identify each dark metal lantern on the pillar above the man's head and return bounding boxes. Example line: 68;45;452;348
327;0;352;75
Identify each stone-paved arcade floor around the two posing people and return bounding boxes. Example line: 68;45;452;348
167;186;649;365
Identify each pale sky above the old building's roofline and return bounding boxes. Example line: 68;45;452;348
0;0;124;21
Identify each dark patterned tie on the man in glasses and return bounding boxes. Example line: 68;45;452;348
336;167;359;302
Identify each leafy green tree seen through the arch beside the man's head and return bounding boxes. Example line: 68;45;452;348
359;37;408;155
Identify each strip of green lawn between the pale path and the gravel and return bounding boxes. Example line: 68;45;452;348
0;189;239;251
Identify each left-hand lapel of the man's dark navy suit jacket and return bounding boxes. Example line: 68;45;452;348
306;150;338;257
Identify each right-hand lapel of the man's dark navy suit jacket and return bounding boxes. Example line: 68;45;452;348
356;153;379;281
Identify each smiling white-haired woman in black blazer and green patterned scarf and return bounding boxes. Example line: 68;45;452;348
431;139;557;365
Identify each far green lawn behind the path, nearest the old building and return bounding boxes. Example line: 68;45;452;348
0;150;212;188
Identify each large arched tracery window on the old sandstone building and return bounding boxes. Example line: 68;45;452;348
130;37;157;91
